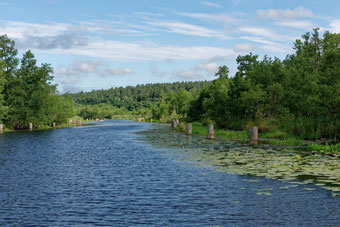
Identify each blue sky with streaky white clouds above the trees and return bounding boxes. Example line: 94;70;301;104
0;0;340;93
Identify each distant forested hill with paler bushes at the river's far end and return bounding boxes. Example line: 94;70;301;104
69;81;212;119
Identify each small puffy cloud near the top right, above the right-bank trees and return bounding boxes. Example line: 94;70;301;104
256;6;314;20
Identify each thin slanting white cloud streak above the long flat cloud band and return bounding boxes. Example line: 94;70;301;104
147;21;229;39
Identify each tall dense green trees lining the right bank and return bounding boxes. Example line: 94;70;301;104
189;29;340;141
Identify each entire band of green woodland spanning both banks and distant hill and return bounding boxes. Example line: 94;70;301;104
0;29;340;139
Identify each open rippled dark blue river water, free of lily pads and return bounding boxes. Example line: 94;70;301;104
0;121;340;226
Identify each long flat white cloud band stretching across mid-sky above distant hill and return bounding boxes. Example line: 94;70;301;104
41;40;235;61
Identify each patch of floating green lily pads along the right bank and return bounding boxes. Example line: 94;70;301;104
140;124;340;196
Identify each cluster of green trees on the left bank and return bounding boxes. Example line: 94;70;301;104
0;35;75;129
